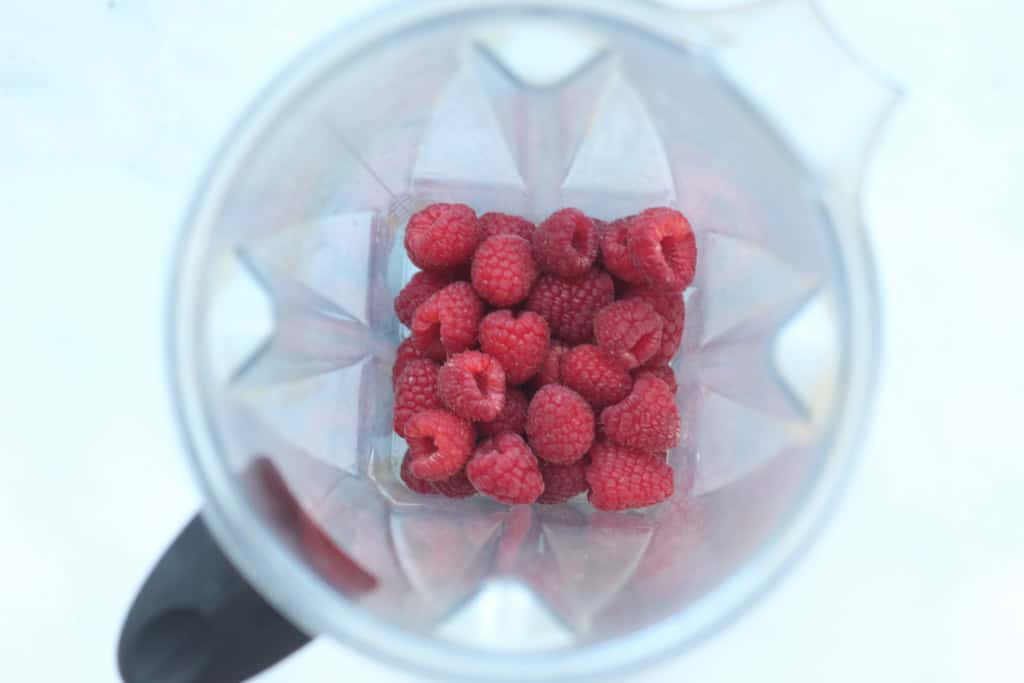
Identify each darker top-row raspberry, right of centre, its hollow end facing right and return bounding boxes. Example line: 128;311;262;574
534;209;598;278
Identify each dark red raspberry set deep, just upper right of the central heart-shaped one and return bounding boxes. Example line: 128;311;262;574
526;269;615;344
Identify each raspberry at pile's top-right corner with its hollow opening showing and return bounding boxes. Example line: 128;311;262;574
629;207;697;292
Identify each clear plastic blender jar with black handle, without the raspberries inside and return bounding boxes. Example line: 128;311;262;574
121;0;895;681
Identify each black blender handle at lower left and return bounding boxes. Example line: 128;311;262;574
118;515;309;683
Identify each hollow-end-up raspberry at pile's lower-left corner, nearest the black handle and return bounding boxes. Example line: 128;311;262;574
406;409;476;481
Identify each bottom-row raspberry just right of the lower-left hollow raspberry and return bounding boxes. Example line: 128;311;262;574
466;432;544;505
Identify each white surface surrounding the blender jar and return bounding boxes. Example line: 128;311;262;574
0;0;1024;683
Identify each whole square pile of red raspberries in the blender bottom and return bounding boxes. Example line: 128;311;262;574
392;204;696;510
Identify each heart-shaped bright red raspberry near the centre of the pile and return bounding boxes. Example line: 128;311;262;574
480;310;551;384
